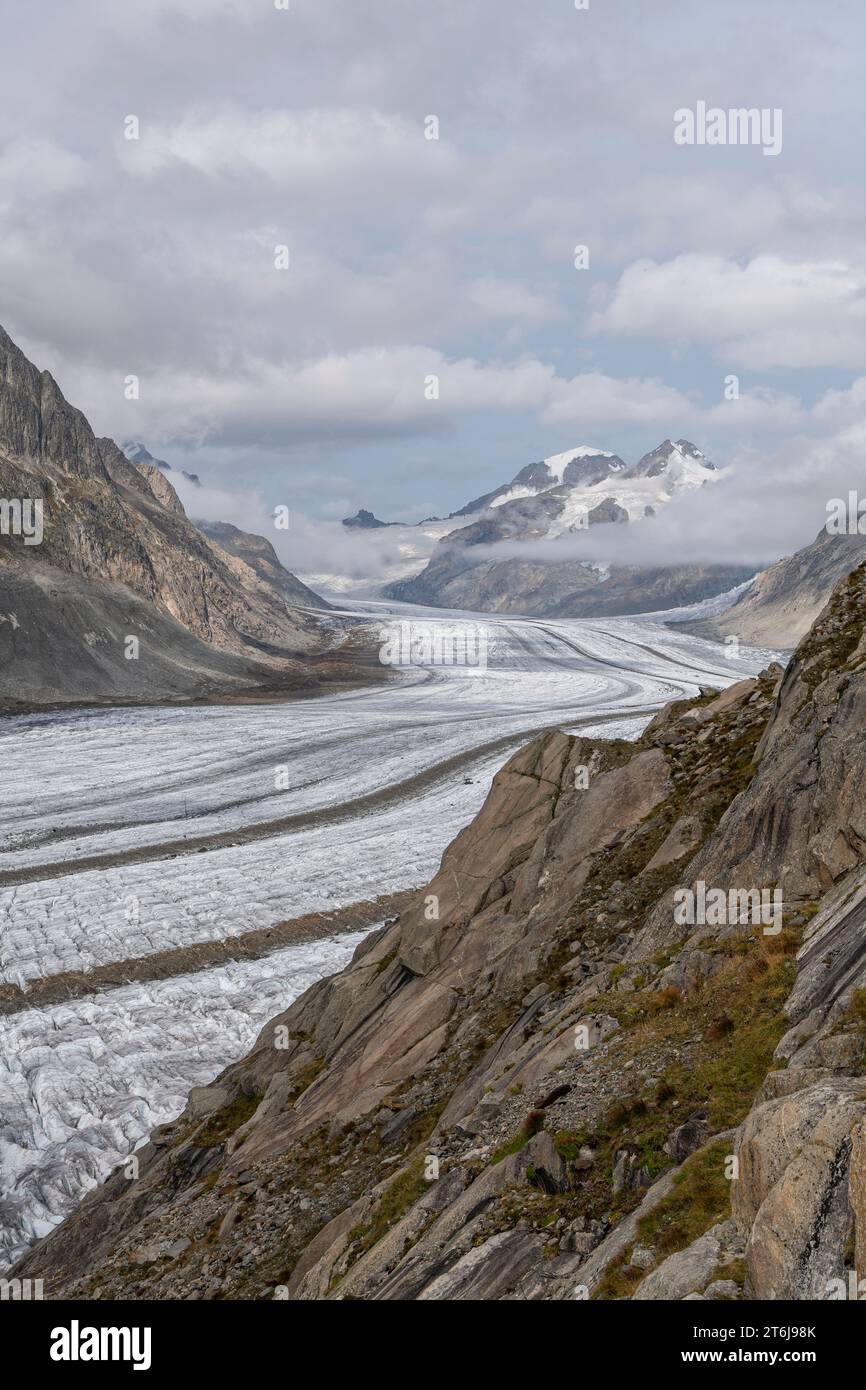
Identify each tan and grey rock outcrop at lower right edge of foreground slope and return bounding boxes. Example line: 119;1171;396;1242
733;850;866;1300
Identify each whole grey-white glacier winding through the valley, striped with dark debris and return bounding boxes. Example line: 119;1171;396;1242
0;605;776;1265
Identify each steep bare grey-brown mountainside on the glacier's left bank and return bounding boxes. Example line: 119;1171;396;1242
0;329;337;702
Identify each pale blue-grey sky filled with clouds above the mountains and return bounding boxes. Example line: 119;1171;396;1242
0;0;866;559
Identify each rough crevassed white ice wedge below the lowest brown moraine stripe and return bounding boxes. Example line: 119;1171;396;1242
0;933;364;1266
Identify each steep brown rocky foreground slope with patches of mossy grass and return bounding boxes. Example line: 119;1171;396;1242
15;569;866;1301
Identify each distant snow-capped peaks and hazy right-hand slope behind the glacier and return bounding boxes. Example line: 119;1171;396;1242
337;439;866;649
